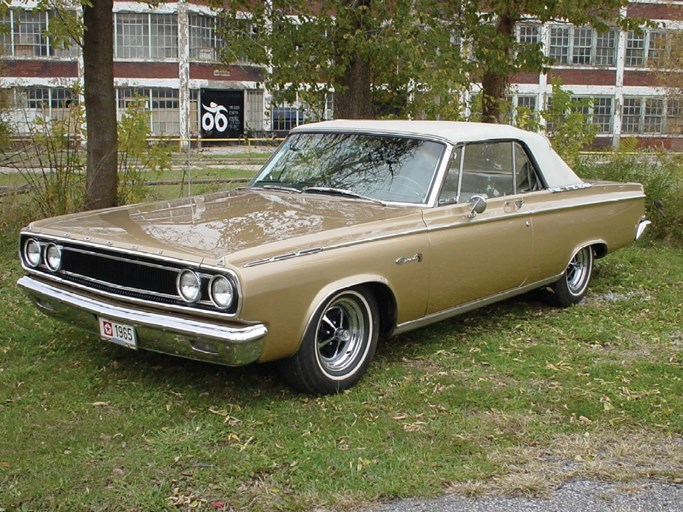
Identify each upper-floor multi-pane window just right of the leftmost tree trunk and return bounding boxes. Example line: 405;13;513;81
114;13;178;59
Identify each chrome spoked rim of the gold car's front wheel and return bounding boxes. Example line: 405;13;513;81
315;296;370;374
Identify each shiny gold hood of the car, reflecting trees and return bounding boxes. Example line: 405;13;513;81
28;189;422;265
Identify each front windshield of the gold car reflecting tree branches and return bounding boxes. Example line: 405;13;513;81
251;133;445;204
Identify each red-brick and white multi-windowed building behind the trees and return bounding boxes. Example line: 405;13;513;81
0;0;683;149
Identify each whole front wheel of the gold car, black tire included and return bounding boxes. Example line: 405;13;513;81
280;288;379;395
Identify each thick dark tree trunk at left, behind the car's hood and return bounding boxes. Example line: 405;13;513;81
83;0;118;210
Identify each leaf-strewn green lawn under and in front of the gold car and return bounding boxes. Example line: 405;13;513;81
0;235;683;511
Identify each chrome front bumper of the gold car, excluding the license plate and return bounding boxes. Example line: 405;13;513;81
17;276;268;366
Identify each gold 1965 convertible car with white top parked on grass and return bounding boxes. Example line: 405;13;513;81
18;121;649;394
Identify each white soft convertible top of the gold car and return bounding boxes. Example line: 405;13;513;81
292;119;583;188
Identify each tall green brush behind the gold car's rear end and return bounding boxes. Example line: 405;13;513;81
576;148;683;246
